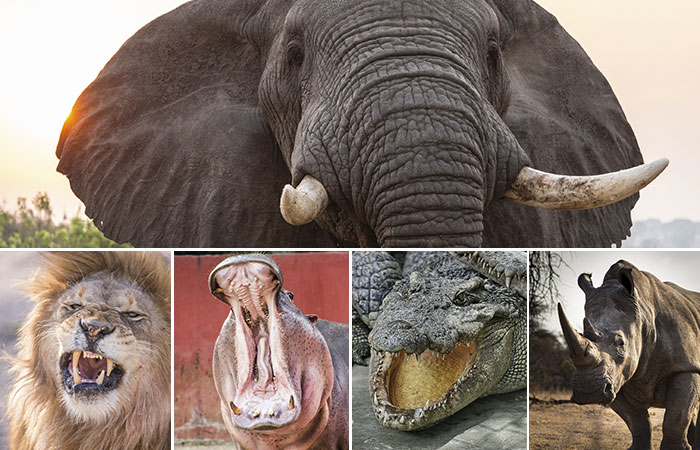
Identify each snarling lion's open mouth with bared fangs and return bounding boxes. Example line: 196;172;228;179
59;350;124;394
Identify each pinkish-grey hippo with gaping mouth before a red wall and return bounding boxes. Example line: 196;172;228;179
209;254;349;449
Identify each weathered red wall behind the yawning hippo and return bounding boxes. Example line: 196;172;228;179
174;252;349;439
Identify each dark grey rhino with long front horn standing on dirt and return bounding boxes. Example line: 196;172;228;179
559;260;700;450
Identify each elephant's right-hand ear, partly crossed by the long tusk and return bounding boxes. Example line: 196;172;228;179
484;0;643;247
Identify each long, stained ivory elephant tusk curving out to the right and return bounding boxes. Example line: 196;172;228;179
505;158;668;210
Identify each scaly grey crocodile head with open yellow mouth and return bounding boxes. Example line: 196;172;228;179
369;255;525;430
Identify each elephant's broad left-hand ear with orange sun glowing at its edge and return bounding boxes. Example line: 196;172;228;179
56;0;330;247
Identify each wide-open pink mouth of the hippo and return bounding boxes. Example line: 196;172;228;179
210;255;300;430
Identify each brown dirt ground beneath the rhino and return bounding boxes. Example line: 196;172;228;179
530;392;664;450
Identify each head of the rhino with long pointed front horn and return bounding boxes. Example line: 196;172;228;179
558;261;644;405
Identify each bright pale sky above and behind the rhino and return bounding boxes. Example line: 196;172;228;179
545;250;700;337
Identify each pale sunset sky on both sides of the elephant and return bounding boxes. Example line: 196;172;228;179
0;0;700;222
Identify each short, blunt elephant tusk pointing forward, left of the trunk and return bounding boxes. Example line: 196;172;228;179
280;175;328;225
